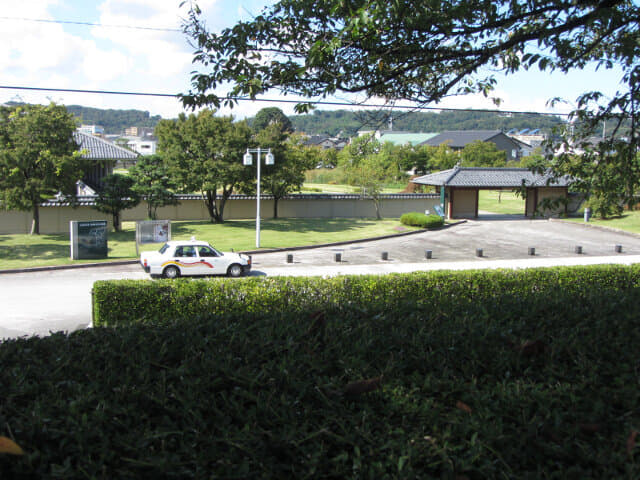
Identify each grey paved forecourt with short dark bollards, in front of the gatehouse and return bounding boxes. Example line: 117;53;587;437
248;216;640;269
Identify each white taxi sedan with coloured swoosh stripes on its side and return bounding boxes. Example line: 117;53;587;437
140;238;251;278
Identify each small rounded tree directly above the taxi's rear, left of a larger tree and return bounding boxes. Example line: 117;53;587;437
129;155;178;220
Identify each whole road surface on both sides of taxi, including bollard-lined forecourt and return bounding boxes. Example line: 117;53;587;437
0;217;640;338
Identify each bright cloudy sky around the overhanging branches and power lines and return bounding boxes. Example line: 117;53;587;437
0;0;632;123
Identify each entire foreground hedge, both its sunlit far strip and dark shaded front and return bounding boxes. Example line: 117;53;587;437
0;267;640;479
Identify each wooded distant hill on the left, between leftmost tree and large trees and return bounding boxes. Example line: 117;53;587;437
66;105;162;135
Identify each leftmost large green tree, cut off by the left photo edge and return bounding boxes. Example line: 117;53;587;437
0;103;86;234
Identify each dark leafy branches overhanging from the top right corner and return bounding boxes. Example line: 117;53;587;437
183;0;640;202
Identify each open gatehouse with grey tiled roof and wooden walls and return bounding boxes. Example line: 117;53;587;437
411;167;571;218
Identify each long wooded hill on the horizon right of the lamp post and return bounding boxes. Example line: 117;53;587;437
289;110;563;137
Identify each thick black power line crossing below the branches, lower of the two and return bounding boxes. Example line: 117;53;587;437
0;85;569;117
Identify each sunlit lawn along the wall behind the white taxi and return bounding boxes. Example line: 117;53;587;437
0;218;412;270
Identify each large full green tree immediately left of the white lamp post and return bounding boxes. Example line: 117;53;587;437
156;110;252;223
